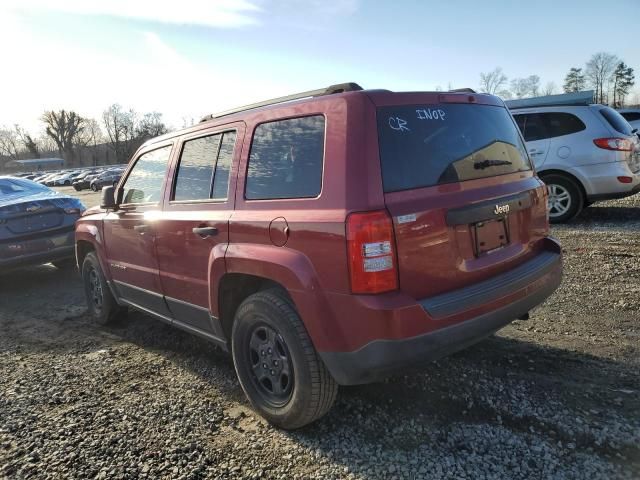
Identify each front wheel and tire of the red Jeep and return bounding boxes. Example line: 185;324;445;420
82;252;125;325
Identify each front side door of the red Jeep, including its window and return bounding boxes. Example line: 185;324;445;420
104;143;172;317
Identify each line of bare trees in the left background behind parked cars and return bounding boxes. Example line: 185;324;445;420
0;104;169;167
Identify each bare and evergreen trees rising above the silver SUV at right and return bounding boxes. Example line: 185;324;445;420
480;52;635;108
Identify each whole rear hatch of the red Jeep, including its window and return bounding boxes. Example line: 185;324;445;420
374;94;548;299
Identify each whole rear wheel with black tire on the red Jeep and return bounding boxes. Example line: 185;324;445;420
231;289;338;430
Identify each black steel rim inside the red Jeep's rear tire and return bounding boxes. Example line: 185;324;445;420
247;324;293;407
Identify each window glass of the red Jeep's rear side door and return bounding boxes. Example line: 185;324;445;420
173;134;222;200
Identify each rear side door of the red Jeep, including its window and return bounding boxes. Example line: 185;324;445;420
156;123;244;339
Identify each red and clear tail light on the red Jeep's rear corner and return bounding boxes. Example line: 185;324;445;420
347;210;398;293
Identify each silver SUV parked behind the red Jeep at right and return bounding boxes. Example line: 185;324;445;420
506;99;640;223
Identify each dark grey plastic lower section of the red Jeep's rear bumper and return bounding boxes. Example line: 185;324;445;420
319;249;562;385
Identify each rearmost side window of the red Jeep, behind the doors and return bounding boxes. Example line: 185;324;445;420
245;115;325;200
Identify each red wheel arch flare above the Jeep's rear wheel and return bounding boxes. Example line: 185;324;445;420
219;244;333;350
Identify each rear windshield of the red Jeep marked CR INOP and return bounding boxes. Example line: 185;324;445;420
378;104;531;192
